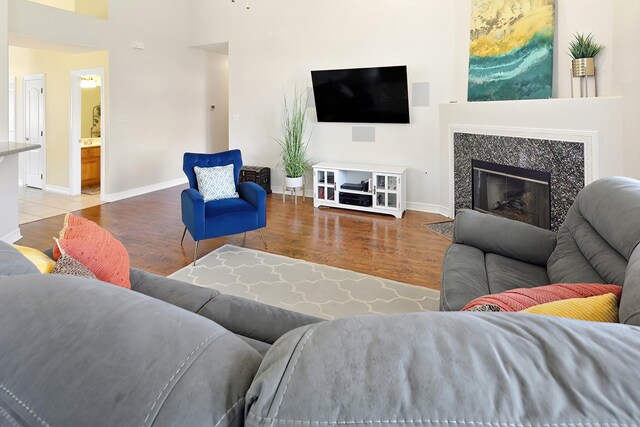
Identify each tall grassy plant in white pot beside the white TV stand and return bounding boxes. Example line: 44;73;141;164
276;89;311;188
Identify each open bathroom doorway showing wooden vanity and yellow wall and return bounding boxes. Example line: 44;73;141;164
69;68;106;200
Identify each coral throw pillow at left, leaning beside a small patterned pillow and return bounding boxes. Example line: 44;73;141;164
53;213;131;289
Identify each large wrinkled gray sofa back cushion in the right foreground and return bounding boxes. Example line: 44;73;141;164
246;313;640;427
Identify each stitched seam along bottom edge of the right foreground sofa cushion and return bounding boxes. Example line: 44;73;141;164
247;413;638;427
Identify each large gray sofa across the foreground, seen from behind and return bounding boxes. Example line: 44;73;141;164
0;175;640;427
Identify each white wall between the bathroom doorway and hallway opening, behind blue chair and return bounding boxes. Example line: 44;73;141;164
9;0;208;200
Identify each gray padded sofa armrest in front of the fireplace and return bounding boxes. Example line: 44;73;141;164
453;209;556;266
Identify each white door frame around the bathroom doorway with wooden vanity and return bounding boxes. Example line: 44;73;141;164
69;67;107;202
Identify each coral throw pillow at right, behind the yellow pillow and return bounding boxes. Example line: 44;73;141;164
462;283;622;311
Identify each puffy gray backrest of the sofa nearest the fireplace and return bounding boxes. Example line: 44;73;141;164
547;177;640;285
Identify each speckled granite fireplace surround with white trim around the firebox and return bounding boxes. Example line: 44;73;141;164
449;125;598;231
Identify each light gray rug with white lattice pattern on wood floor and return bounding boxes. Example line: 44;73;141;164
169;245;440;319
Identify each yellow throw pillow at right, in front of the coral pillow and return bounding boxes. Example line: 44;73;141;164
520;294;619;323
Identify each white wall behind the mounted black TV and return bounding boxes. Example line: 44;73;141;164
190;0;454;211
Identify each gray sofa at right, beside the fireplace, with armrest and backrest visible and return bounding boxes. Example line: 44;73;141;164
440;177;640;321
